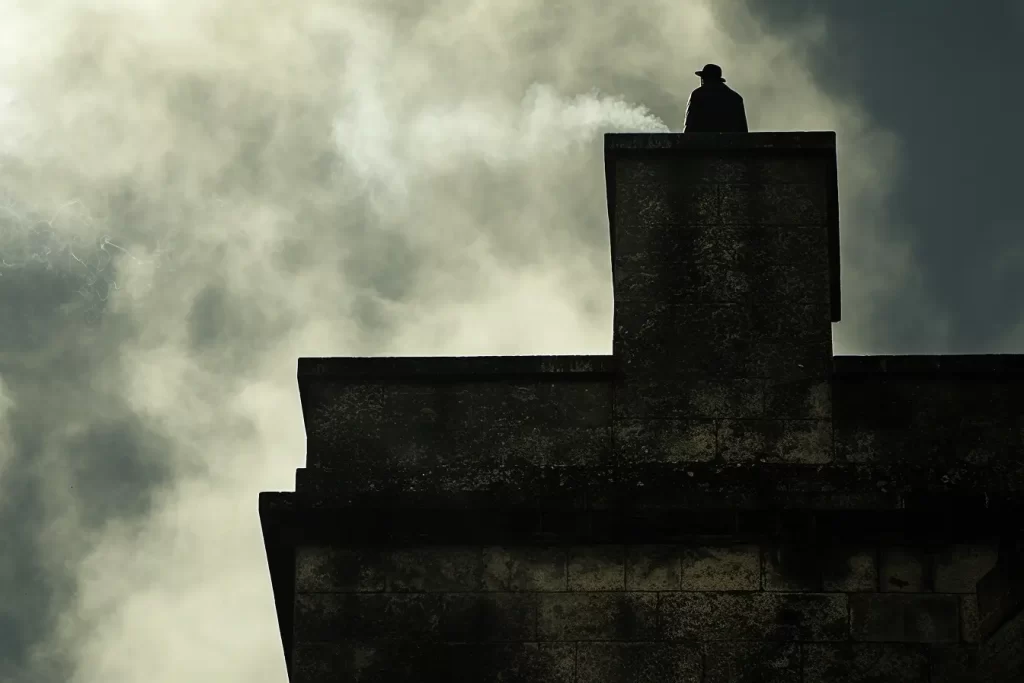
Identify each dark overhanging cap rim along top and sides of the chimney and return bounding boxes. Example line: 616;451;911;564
604;131;843;323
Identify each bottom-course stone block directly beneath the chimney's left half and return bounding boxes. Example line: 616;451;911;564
575;643;701;683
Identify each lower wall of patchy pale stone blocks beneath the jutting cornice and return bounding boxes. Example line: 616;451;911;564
293;539;995;683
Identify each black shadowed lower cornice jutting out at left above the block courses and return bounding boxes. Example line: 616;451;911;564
259;492;1008;673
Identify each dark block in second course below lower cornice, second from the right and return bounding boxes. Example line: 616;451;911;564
850;593;959;643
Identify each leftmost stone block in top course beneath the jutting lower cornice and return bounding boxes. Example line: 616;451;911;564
295;546;386;593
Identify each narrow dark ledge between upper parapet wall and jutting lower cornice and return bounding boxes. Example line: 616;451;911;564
296;462;1024;511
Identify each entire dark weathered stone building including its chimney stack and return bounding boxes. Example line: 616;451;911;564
260;132;1024;683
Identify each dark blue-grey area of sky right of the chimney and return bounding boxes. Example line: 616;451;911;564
749;0;1024;353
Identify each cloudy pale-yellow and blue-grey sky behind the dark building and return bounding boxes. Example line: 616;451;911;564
0;0;1024;683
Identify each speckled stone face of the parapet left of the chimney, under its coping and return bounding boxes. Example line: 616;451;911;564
302;379;612;480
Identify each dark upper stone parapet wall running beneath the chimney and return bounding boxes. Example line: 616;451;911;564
298;356;1024;508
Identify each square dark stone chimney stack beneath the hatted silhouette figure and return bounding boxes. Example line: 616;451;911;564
605;132;840;379
